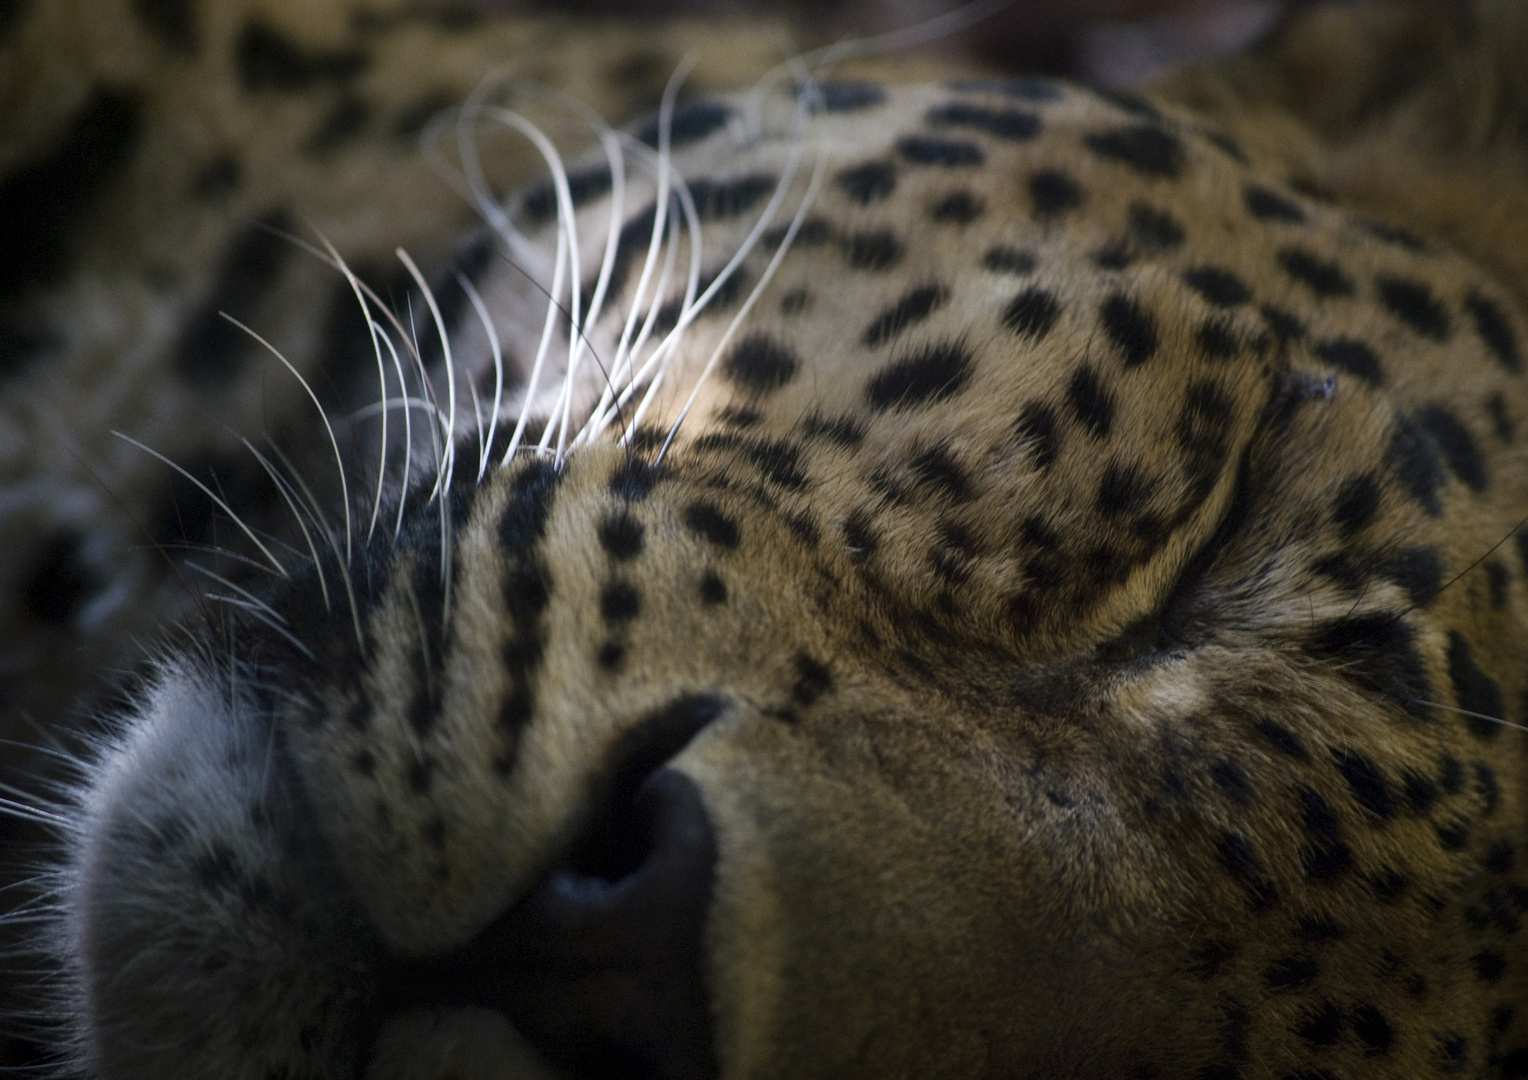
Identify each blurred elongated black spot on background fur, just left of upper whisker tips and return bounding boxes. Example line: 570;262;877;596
174;215;295;388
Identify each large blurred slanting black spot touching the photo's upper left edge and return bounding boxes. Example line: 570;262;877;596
0;87;144;301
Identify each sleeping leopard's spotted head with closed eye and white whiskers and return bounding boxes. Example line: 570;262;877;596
17;2;1528;1080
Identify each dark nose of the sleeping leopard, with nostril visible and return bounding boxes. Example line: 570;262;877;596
378;697;724;1080
